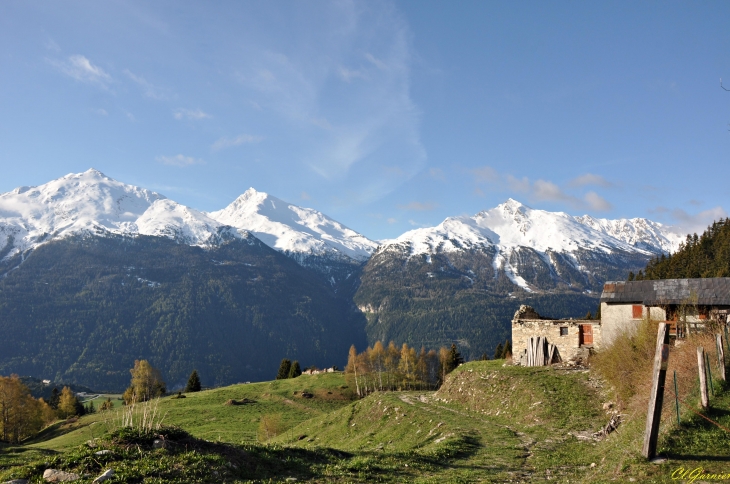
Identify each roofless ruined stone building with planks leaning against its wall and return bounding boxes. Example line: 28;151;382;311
512;305;602;366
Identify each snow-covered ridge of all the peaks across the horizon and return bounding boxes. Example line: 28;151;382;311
0;168;683;274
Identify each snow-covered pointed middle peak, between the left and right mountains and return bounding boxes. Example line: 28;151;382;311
208;188;378;262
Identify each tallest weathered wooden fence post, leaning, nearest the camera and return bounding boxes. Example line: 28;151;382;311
641;323;669;459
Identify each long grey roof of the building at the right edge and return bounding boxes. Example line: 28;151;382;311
601;277;730;306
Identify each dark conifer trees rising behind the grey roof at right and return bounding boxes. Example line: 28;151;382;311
629;218;730;280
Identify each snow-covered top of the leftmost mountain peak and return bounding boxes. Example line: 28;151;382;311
0;169;241;257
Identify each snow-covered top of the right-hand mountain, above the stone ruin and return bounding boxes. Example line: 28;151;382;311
375;199;681;291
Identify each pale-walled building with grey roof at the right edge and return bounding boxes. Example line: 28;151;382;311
601;277;730;345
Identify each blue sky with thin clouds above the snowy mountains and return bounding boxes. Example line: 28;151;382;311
0;0;730;239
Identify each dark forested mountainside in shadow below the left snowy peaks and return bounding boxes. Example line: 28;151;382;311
0;236;366;391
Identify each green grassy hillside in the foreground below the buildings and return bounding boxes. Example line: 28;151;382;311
0;361;730;483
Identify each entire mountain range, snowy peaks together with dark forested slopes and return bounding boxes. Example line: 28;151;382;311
0;169;682;389
